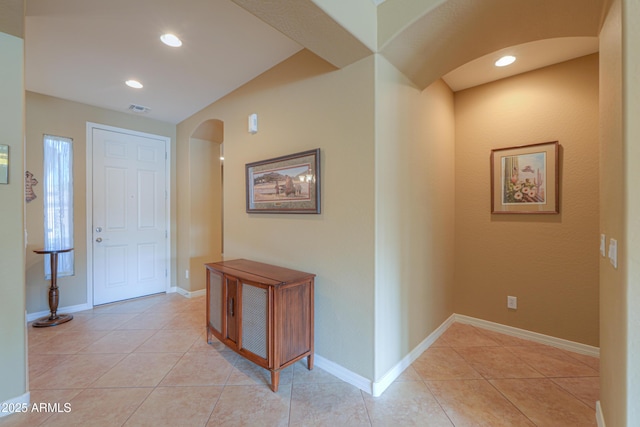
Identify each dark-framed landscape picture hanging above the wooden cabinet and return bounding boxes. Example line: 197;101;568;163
246;148;320;214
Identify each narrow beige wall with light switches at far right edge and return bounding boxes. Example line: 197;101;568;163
600;0;640;426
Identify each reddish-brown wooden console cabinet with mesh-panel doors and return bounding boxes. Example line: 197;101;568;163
206;259;315;391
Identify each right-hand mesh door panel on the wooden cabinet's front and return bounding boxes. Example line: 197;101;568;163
242;283;267;359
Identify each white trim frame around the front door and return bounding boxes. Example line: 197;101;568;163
85;122;172;308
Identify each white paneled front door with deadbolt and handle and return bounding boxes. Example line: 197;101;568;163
91;127;168;305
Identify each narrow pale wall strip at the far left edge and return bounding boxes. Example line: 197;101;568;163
0;24;27;404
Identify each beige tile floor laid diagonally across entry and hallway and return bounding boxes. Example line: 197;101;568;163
0;294;599;427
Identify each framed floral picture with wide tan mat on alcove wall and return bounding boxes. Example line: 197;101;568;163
491;141;560;214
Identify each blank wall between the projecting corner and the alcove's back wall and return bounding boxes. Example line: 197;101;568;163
373;56;455;381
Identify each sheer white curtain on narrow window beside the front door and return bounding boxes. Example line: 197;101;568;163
44;135;74;278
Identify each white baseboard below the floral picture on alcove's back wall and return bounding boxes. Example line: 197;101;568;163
454;314;600;357
